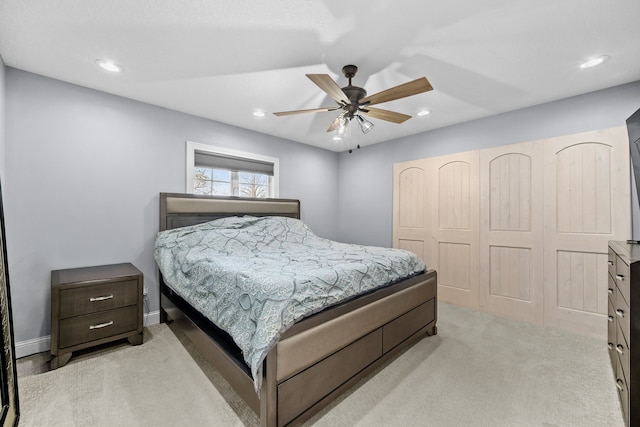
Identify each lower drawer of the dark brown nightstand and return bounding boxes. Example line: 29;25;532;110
59;305;138;349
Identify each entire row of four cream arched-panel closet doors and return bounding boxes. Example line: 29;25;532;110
393;127;631;338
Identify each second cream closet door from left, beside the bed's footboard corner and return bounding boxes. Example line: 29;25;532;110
426;151;479;309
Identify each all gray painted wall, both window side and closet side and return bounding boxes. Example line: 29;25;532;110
5;64;640;352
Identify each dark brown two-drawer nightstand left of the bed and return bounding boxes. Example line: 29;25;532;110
51;263;144;369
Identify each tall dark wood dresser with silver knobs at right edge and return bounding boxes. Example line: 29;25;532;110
607;241;640;426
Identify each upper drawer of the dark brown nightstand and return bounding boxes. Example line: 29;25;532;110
60;280;140;319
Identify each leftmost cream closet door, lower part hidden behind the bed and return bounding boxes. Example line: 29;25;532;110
393;160;432;260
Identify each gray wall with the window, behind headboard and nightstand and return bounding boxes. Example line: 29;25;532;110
5;68;338;342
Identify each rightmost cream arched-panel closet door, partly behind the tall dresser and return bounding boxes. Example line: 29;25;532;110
544;127;631;337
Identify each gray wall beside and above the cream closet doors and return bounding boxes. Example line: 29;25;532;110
338;82;640;246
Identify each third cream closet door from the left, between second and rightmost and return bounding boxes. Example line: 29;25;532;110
480;142;544;324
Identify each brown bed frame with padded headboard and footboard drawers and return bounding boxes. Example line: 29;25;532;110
160;193;437;426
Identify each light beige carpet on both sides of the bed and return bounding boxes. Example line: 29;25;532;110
18;303;624;427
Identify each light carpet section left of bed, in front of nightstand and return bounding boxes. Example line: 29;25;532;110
18;324;248;426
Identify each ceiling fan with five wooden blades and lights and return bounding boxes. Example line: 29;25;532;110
273;65;433;133
